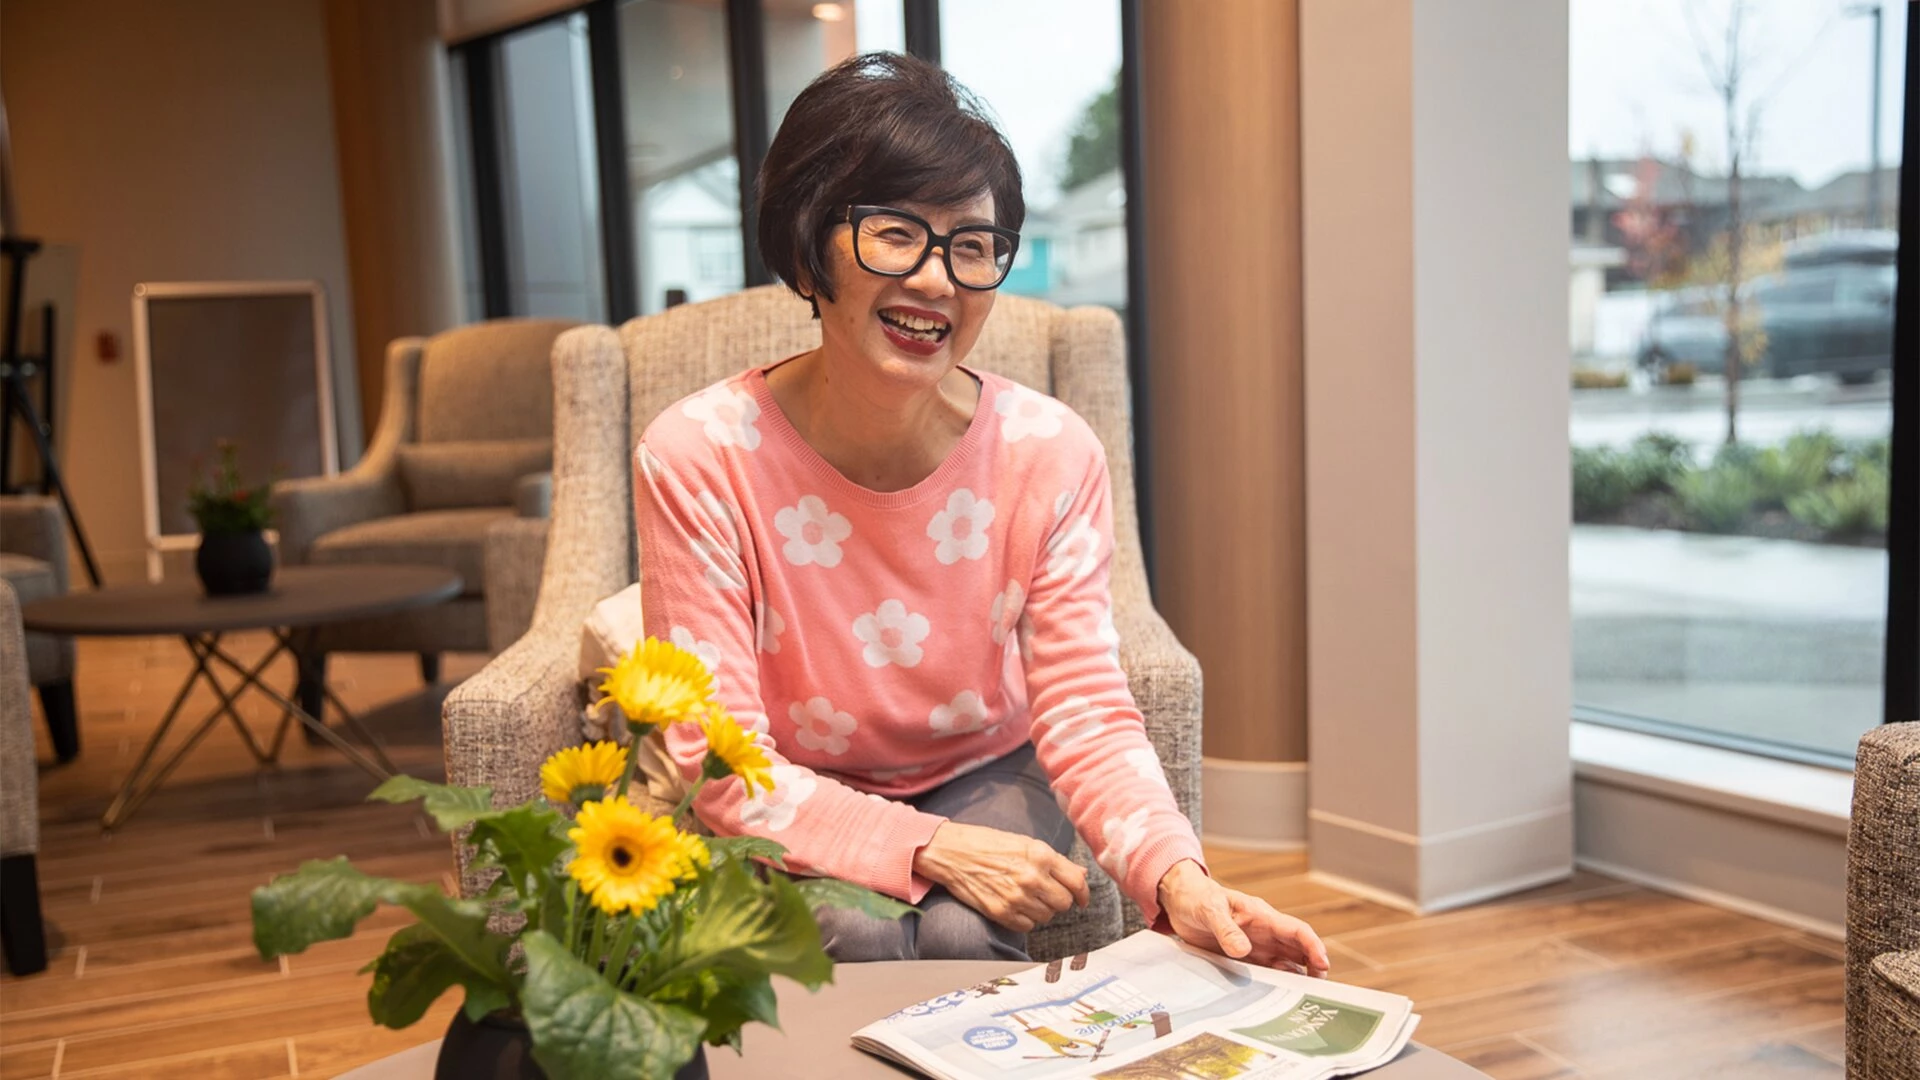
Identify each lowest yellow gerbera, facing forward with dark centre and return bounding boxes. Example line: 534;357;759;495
566;796;689;915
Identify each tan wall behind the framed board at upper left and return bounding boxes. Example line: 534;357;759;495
0;0;361;580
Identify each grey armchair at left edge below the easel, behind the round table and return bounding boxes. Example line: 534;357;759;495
0;496;81;763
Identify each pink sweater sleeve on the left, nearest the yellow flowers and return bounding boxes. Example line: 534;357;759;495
634;442;947;903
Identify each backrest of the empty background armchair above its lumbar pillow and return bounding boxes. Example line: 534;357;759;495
413;319;578;442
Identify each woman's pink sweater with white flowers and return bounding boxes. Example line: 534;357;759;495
634;359;1204;922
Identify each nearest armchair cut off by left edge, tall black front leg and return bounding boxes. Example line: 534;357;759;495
0;580;46;974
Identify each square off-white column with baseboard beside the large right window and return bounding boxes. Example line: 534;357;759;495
1300;0;1572;911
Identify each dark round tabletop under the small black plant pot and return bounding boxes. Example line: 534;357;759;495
21;565;463;636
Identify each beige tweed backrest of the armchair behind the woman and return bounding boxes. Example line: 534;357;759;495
620;284;1146;596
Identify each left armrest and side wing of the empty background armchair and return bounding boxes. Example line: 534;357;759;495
273;338;424;565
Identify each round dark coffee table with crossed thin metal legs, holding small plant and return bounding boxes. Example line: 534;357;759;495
21;565;461;828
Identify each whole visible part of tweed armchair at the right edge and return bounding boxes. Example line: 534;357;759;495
1847;723;1920;1080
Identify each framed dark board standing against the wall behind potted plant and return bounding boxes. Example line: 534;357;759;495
132;281;340;580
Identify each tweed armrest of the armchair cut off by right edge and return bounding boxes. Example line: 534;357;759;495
1847;723;1920;1076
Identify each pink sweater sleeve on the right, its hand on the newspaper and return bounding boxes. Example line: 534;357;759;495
1021;444;1206;924
